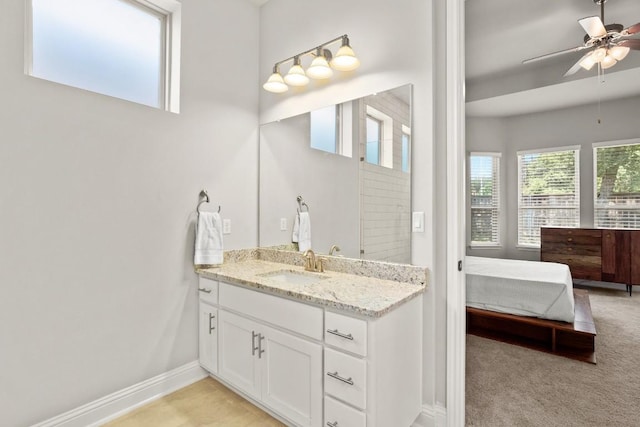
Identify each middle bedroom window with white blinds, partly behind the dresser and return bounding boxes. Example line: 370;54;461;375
518;146;580;248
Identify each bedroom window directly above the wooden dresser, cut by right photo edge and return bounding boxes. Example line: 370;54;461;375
593;139;640;229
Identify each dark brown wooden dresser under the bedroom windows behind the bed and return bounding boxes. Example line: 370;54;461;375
540;228;640;295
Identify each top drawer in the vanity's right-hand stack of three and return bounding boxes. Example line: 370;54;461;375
324;312;367;356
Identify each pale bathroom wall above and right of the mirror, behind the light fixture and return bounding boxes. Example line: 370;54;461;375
260;0;446;412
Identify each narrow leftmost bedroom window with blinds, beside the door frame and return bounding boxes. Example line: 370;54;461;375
469;153;500;246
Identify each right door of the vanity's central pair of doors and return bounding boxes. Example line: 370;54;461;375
260;328;322;427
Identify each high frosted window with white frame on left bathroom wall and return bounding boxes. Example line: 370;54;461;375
25;0;180;112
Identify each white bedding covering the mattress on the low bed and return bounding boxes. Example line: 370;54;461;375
465;256;574;323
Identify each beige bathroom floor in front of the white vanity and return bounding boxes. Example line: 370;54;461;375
105;378;284;427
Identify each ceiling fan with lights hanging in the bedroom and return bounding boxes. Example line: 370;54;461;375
522;0;640;77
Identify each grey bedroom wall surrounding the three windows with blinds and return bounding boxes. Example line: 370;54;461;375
467;95;640;260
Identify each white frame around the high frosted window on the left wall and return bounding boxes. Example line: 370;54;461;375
24;0;182;113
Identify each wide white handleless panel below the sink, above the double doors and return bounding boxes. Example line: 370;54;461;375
219;282;323;341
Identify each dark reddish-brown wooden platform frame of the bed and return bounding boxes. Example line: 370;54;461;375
467;289;596;364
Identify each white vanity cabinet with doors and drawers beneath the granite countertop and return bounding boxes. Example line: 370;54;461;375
200;279;422;427
